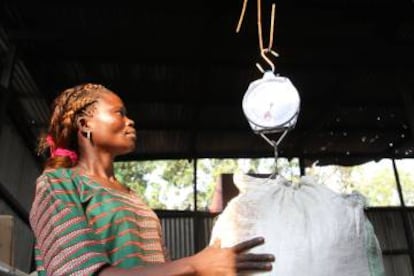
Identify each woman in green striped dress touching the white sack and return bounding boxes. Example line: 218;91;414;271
30;84;274;275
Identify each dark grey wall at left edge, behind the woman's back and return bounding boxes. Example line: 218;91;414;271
0;117;40;272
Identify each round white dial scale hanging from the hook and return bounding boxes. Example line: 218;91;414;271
243;72;300;132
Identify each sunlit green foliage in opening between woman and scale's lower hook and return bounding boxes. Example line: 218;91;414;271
115;159;298;210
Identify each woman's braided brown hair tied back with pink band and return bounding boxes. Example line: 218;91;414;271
38;83;109;168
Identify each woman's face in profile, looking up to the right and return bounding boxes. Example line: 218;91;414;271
87;92;136;156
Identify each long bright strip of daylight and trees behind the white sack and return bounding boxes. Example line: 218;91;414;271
115;158;414;211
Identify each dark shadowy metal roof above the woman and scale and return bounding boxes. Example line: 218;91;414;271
0;0;414;164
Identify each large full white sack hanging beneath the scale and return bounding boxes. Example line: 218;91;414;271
211;174;385;276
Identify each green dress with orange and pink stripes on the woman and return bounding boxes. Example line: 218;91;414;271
30;168;165;275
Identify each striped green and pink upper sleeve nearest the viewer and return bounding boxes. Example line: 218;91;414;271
30;174;109;275
